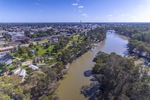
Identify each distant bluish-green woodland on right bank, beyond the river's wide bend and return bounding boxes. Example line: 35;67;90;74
109;23;150;59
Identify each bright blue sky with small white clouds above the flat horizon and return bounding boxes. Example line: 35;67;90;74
0;0;150;23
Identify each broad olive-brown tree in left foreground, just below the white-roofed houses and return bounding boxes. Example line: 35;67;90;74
26;67;57;100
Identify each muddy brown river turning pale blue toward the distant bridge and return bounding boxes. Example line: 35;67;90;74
56;32;128;100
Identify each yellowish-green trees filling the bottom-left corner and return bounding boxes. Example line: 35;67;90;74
0;75;30;100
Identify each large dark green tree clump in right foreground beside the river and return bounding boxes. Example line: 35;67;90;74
81;52;150;100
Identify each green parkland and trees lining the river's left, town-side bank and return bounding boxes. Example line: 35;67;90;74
0;28;106;100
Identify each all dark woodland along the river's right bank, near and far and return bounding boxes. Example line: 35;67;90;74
81;24;150;100
